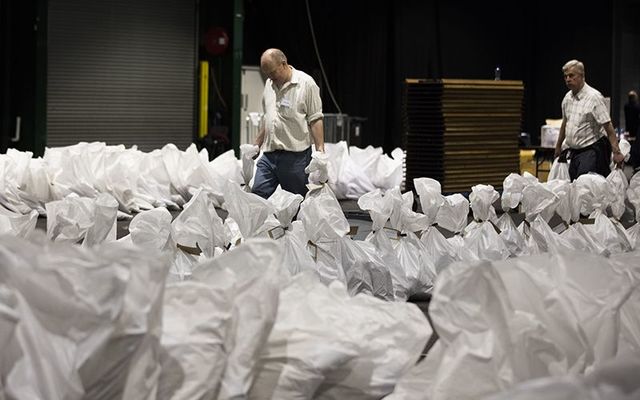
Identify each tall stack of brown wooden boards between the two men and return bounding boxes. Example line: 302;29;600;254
402;79;524;193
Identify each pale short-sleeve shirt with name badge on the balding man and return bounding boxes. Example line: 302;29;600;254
262;66;323;152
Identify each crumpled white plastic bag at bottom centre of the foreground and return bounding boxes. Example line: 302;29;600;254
249;274;431;399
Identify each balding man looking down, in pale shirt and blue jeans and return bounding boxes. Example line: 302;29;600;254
252;49;324;198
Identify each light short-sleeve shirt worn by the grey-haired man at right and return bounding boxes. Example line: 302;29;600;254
562;83;611;149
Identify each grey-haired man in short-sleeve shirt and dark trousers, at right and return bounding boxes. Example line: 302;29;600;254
555;60;624;180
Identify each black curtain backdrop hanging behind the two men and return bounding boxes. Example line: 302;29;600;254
244;0;640;151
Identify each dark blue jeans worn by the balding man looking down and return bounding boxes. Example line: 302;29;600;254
252;147;311;199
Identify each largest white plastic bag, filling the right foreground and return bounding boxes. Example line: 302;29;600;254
388;252;637;400
